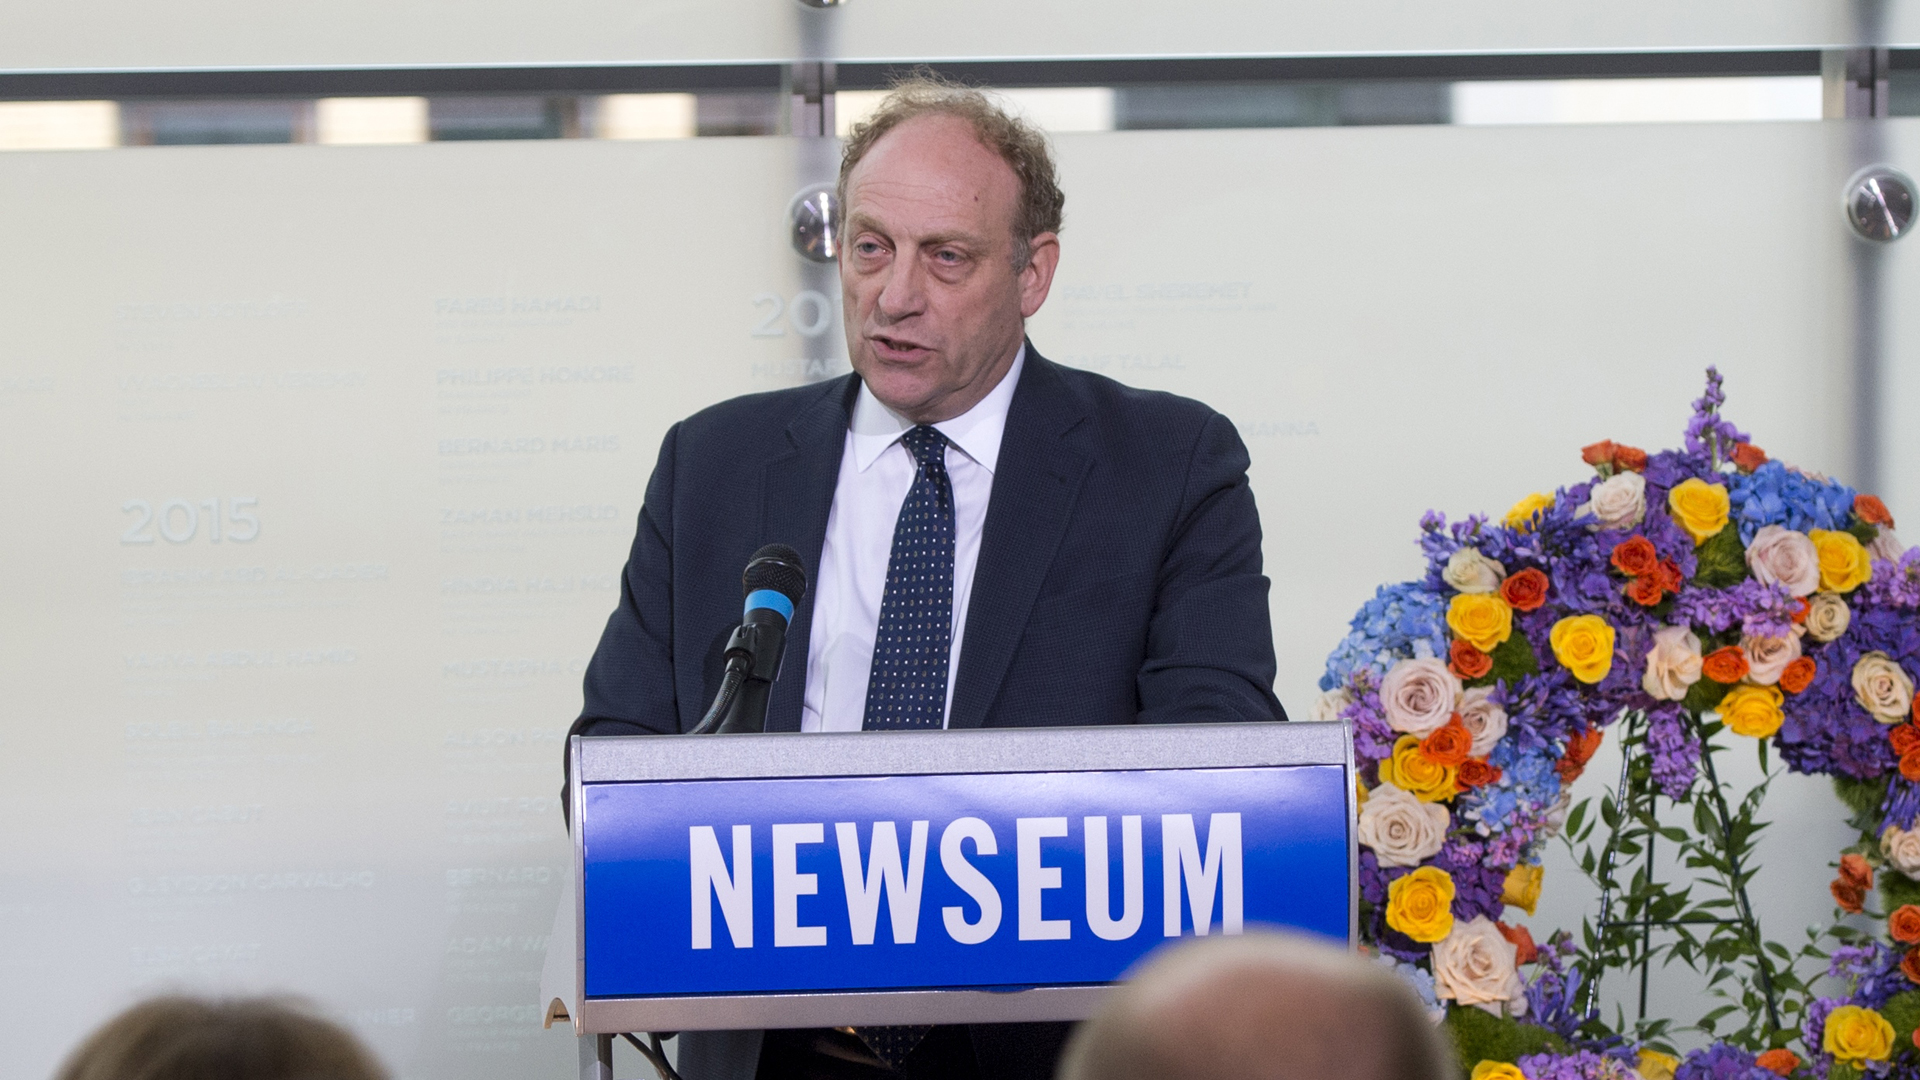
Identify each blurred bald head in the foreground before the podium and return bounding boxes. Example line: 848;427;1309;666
1058;932;1457;1080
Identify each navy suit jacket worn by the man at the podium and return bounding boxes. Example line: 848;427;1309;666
574;344;1286;734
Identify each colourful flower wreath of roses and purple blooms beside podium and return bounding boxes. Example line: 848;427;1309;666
1315;369;1920;1080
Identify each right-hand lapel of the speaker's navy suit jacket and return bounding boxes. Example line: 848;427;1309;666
947;342;1091;728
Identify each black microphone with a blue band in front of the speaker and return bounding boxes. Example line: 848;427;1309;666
689;544;806;734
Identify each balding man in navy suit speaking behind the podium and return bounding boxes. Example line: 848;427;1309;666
574;79;1286;1080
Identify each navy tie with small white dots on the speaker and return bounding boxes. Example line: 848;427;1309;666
860;425;954;730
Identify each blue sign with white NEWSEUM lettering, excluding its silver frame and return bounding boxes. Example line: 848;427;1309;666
582;765;1350;997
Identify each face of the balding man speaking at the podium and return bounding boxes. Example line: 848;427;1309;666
841;115;1060;423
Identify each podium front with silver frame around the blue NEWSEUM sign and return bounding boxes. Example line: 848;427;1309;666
568;723;1356;1032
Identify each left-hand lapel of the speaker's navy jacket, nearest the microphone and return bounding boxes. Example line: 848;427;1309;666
760;375;860;732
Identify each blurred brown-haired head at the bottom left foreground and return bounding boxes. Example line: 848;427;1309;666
56;997;386;1080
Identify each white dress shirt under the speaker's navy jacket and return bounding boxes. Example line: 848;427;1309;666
801;344;1027;732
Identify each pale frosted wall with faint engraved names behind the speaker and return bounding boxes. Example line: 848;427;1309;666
0;122;1920;1078
